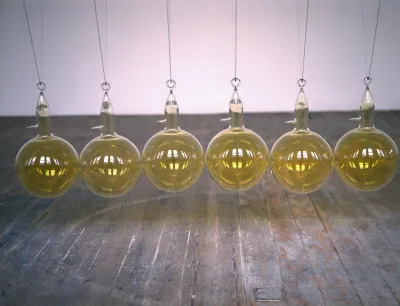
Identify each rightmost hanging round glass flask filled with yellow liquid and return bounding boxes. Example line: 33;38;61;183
334;86;398;191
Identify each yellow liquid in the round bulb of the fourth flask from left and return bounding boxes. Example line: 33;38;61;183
206;128;268;190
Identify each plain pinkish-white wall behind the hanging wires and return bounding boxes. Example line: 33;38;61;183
0;0;400;115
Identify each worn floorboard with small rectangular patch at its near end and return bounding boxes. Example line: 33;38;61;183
238;184;283;304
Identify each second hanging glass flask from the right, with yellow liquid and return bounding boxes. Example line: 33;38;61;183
271;88;333;193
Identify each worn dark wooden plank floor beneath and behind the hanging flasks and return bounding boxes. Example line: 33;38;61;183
0;112;400;306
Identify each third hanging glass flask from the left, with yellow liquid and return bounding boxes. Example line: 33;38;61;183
143;90;204;192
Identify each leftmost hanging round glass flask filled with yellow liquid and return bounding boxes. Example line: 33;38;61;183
15;91;79;198
